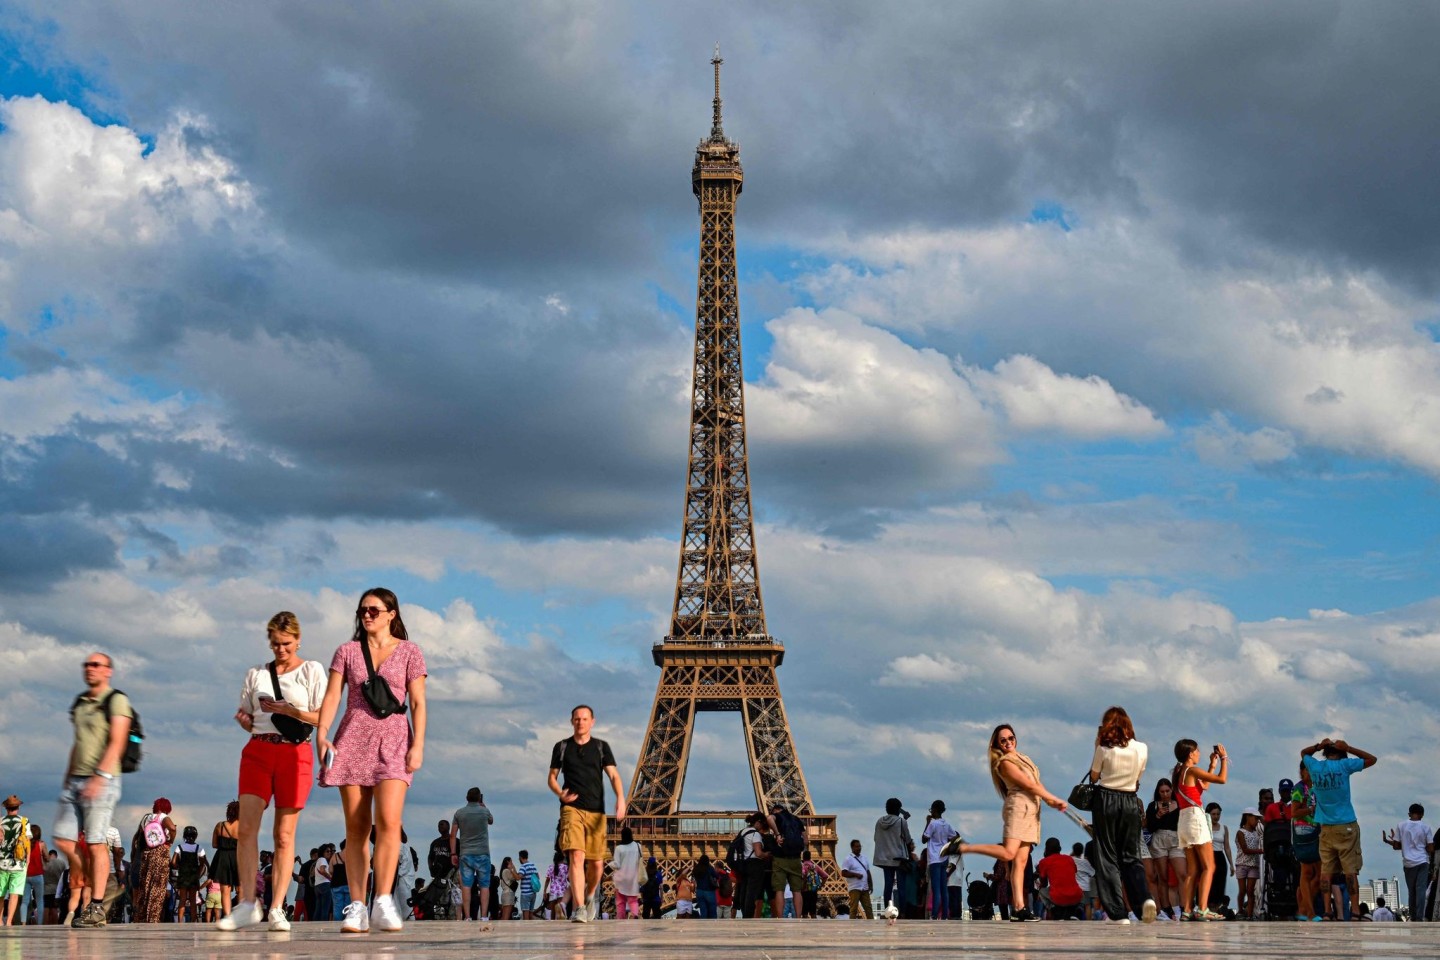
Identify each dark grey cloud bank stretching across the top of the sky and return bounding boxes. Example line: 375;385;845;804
28;3;1440;289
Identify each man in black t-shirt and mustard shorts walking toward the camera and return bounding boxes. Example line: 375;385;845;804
550;704;625;924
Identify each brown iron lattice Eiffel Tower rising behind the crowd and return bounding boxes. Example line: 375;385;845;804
611;47;845;910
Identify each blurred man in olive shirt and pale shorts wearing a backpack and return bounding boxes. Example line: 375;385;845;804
50;653;135;927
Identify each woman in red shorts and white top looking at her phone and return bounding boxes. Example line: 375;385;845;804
216;610;325;930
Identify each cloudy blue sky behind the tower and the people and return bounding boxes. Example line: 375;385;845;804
0;0;1440;878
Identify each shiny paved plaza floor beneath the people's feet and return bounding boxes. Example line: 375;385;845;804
0;920;1440;960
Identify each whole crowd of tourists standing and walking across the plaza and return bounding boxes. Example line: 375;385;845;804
0;587;1440;934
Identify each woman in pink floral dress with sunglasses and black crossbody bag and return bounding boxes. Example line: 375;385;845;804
315;587;425;933
